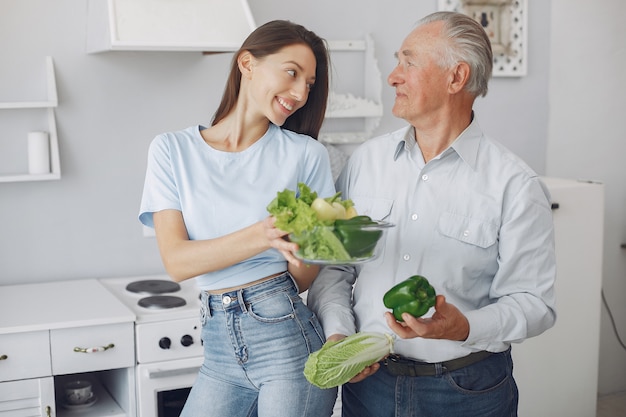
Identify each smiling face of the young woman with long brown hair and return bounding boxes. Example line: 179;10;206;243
242;44;317;126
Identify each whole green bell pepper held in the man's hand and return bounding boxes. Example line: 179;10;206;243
383;275;436;321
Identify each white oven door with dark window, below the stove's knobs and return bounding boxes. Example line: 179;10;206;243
136;357;203;417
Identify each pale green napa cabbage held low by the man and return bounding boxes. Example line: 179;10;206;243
304;332;394;388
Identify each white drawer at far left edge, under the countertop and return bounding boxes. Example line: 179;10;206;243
0;330;52;381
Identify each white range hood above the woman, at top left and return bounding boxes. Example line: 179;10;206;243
87;0;256;53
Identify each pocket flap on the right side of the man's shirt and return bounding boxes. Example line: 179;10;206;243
437;212;498;249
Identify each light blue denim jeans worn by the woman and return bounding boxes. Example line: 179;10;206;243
181;273;337;417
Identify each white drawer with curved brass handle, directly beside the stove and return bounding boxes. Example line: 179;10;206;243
50;322;135;375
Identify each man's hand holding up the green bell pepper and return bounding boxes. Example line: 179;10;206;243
385;295;469;341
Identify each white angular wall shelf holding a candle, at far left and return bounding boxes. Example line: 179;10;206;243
0;56;61;182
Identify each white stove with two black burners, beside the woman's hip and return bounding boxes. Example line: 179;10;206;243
99;275;203;417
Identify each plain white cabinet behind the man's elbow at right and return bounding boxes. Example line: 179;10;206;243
512;178;604;417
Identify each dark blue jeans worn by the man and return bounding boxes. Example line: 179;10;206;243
341;349;518;417
